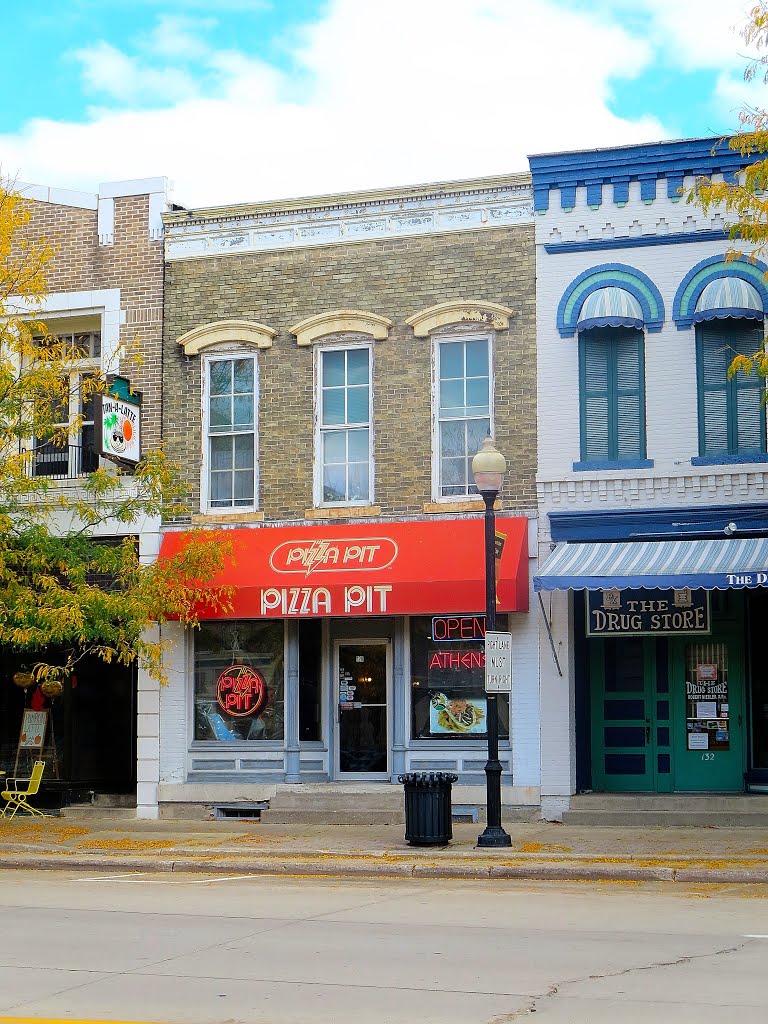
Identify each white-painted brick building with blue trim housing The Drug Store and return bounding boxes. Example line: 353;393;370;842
530;139;768;818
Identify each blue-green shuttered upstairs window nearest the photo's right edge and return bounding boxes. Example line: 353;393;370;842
696;318;766;459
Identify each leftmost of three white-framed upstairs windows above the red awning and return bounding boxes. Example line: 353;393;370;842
206;355;257;511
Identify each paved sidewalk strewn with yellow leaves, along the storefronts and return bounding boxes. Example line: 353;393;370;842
0;815;768;883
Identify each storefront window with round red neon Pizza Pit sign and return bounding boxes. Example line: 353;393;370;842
195;622;285;742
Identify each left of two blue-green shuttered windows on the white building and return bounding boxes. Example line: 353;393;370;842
581;327;645;468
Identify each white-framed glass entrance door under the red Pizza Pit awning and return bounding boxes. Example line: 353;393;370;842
336;640;390;778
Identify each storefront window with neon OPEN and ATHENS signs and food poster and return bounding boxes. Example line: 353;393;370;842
411;615;509;739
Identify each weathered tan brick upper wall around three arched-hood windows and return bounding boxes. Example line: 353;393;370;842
163;224;536;519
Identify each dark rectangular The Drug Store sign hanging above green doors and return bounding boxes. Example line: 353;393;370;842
587;587;712;637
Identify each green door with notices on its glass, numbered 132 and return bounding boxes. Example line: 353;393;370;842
670;631;745;793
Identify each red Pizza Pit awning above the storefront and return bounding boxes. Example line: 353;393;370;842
160;516;528;618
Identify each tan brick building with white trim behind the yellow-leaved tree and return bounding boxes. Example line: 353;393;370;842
0;178;166;813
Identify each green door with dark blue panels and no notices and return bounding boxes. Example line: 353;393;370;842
590;637;672;793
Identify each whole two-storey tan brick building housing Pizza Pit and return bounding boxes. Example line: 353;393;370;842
154;175;539;804
